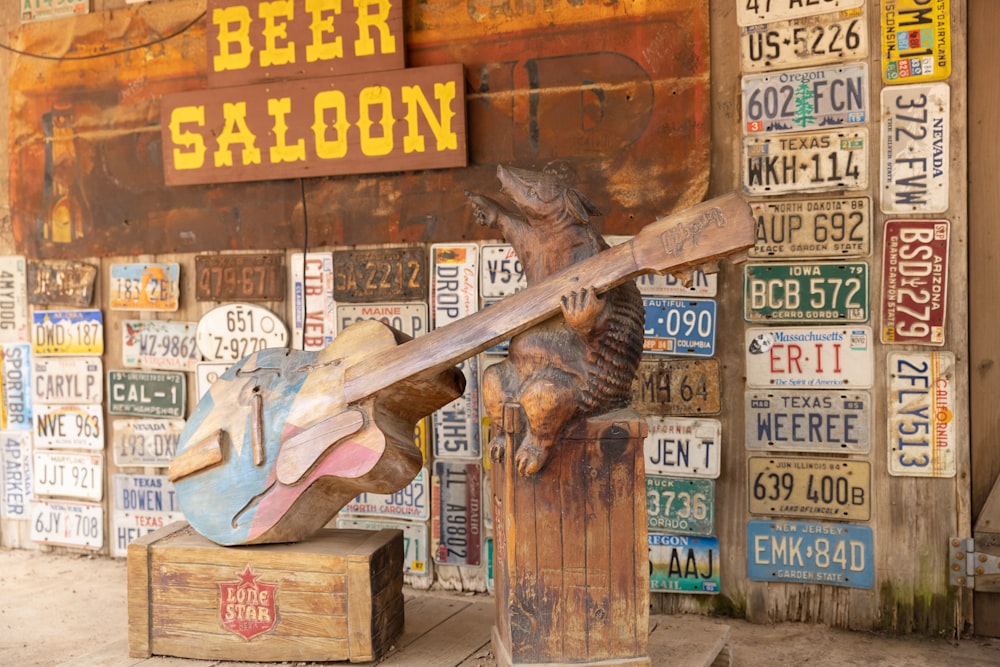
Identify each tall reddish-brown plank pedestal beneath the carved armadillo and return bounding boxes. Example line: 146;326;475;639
491;410;650;667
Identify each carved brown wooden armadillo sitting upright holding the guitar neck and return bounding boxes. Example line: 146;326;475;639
469;166;644;475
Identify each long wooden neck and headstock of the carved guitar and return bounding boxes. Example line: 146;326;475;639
344;195;754;404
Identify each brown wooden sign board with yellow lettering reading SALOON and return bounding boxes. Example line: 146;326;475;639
160;64;468;185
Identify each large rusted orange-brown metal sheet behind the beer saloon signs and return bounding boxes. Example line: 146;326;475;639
10;0;710;258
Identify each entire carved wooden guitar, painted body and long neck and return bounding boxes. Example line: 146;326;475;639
169;190;754;545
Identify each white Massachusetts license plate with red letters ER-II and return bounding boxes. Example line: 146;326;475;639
745;326;874;389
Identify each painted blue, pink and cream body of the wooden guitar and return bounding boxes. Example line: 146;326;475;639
170;321;464;545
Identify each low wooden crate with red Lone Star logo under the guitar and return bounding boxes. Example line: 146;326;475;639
128;522;403;662
